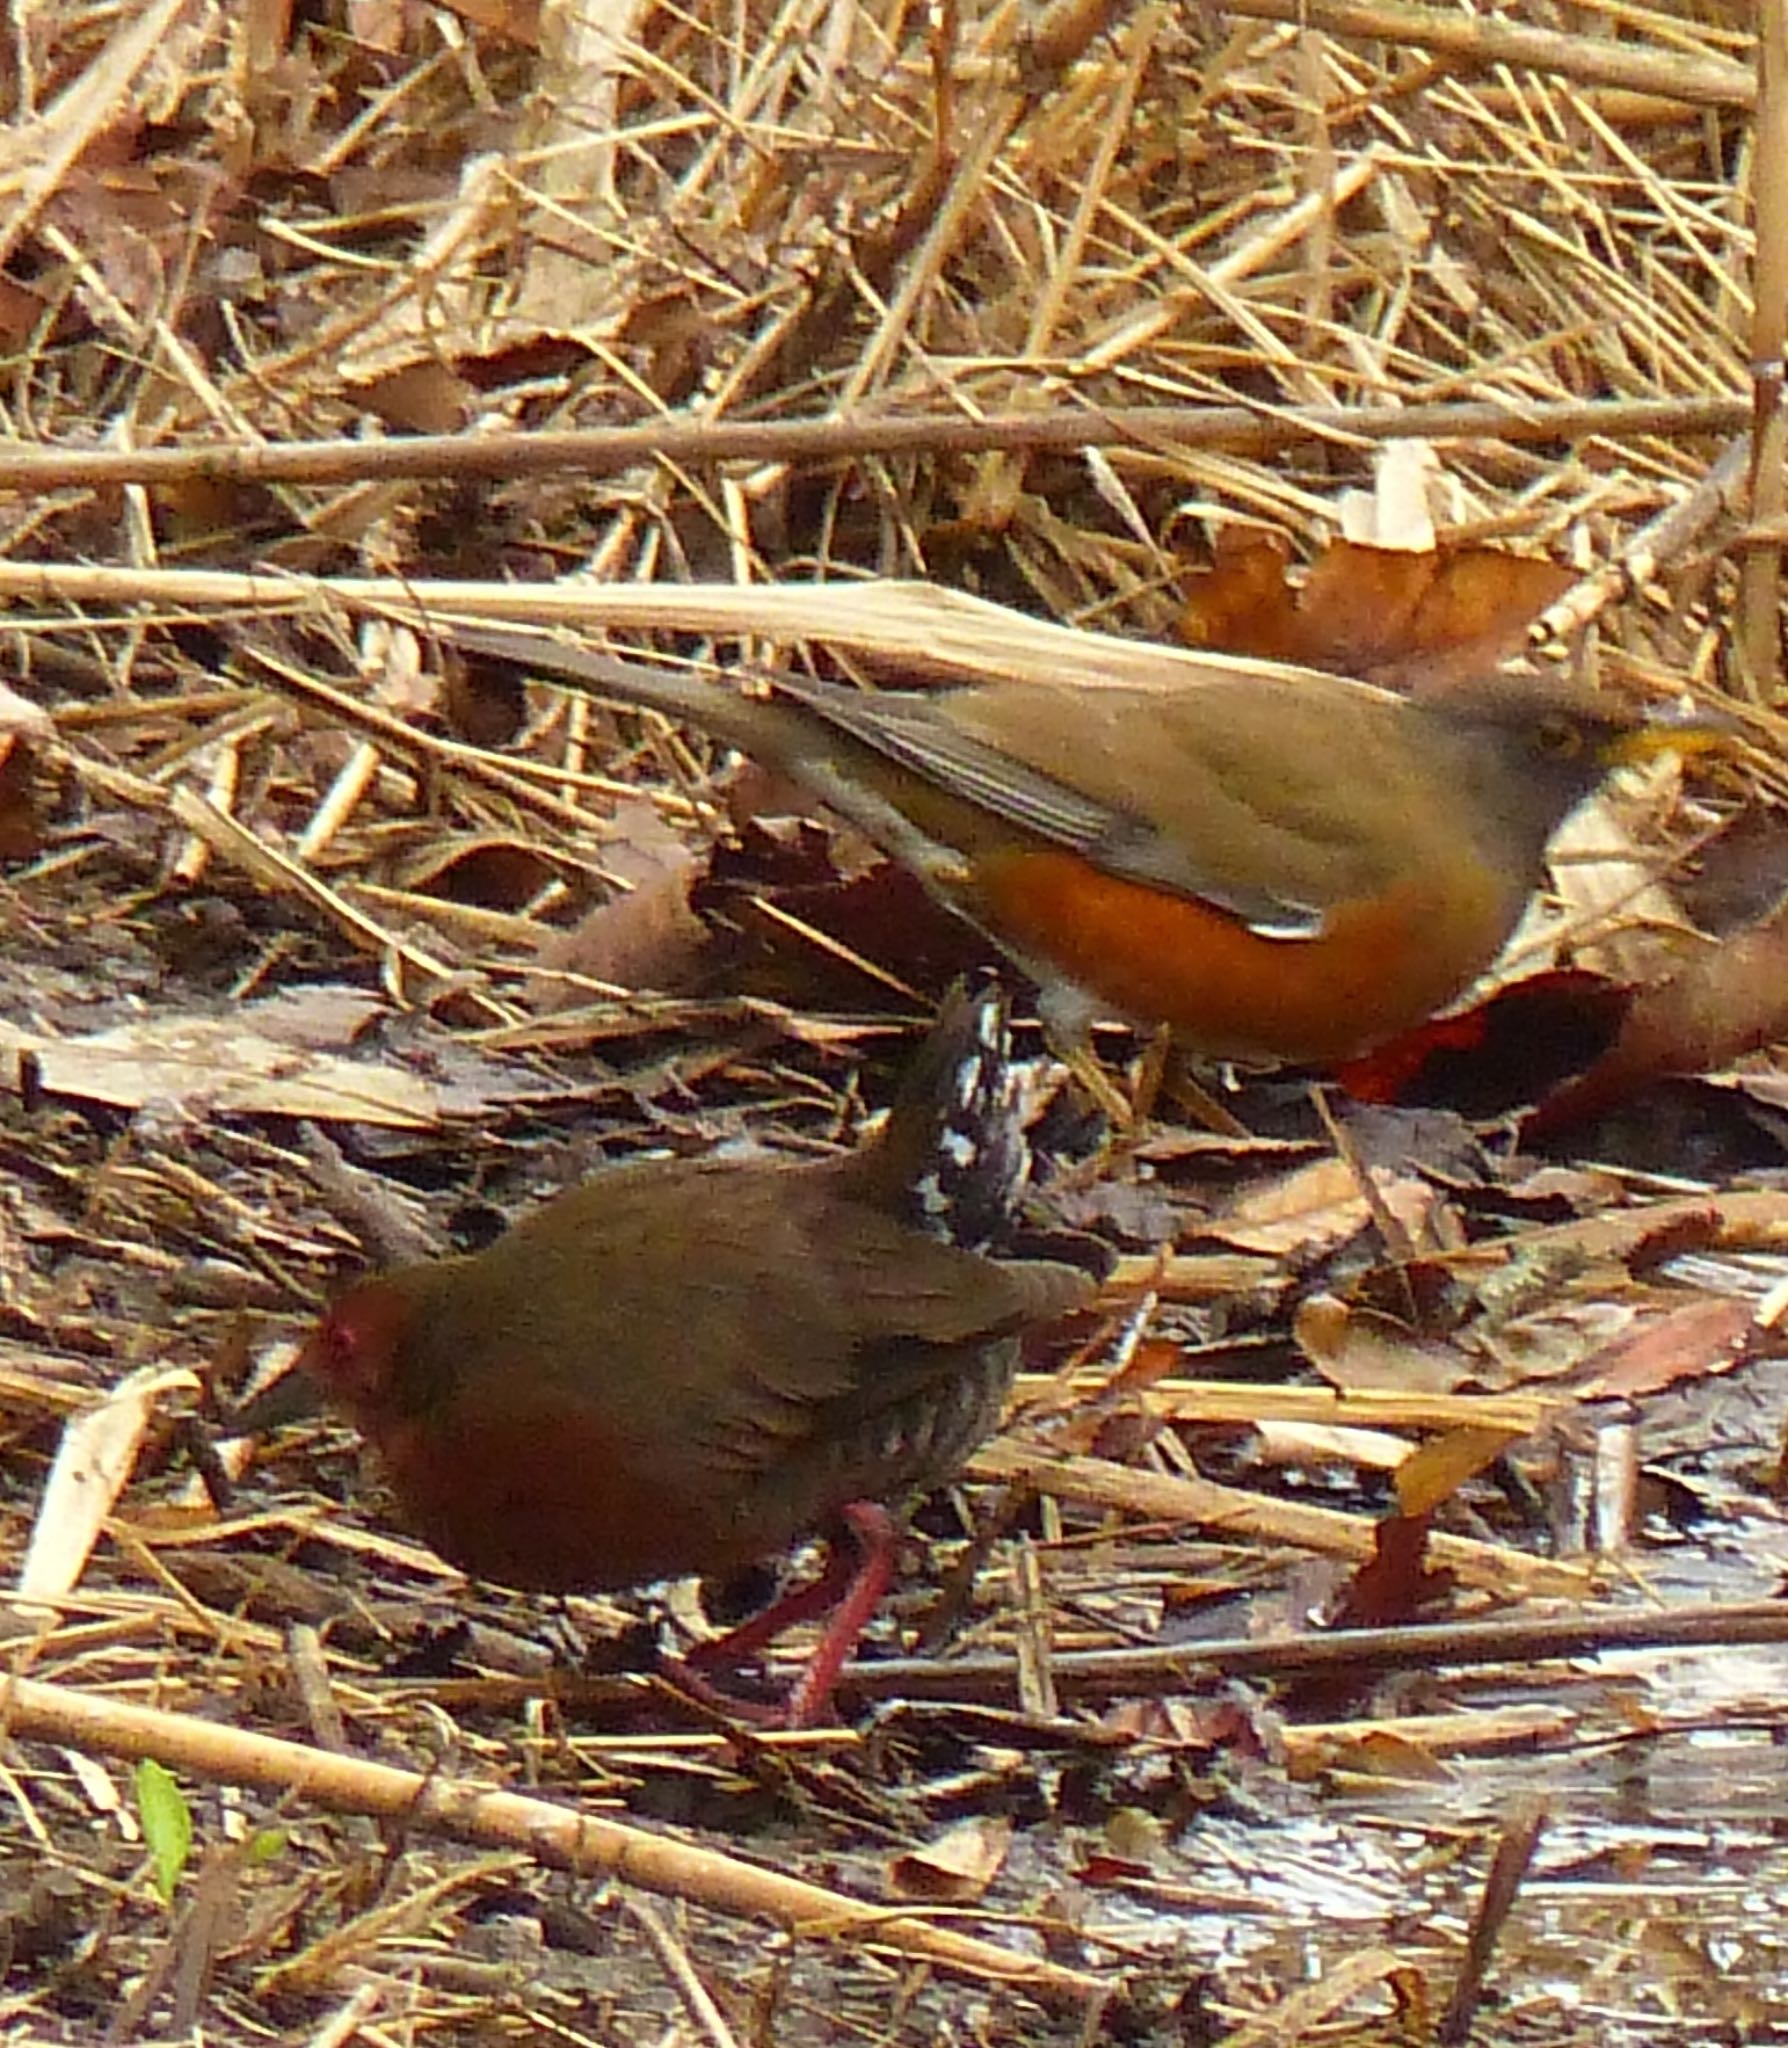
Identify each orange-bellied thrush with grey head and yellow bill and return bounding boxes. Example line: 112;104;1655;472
440;625;1710;1063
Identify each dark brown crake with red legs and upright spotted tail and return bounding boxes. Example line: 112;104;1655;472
282;989;1092;1726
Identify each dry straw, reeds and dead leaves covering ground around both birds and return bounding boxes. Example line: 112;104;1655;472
0;0;1788;2044
